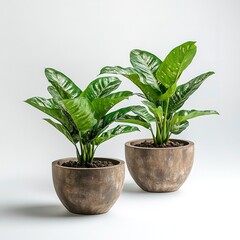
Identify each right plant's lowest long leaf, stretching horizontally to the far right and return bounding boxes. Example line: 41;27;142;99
171;110;218;125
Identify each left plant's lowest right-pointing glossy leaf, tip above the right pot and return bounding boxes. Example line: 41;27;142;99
94;125;139;145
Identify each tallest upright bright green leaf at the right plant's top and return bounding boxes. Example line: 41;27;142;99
156;42;197;88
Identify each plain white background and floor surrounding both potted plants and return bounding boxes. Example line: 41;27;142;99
0;0;240;240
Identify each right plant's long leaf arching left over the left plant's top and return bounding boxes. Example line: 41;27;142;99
100;66;160;103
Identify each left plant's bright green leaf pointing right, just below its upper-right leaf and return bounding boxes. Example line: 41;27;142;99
92;97;126;119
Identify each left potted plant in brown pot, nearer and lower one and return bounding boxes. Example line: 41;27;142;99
26;68;141;214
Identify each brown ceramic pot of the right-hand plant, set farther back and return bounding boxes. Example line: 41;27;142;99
125;139;194;192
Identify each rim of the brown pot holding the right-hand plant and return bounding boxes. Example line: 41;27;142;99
125;138;194;151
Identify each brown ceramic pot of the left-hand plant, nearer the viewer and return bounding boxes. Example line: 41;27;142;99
52;158;125;214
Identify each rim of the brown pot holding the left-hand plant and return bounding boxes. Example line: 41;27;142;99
52;157;125;171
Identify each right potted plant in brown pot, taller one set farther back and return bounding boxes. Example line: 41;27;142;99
101;41;218;192
